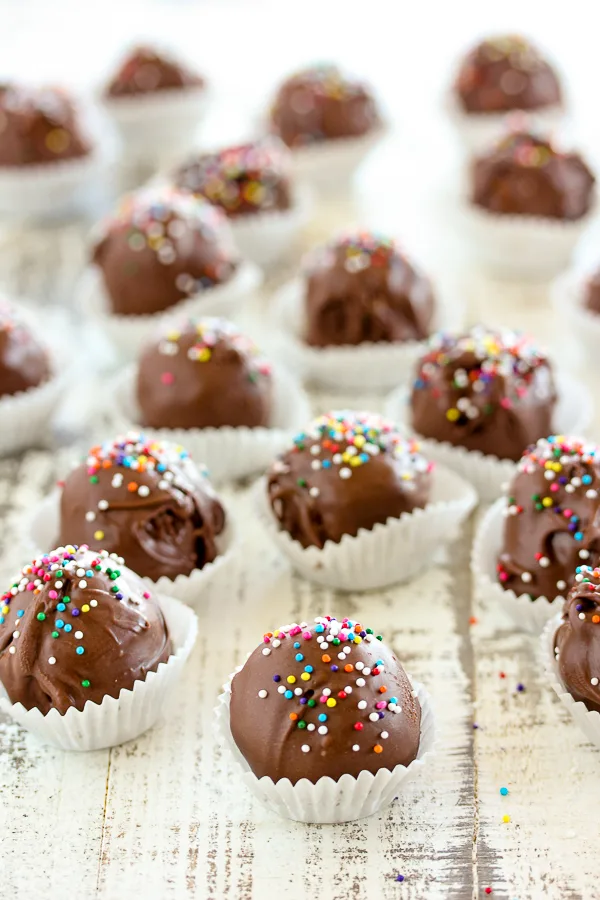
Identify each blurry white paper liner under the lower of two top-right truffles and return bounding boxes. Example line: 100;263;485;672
458;200;597;280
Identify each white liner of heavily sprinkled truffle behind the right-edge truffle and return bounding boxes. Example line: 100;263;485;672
384;372;594;503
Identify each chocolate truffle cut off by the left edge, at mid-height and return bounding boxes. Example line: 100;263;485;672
0;300;51;397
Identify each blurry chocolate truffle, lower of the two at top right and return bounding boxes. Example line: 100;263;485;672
471;131;595;221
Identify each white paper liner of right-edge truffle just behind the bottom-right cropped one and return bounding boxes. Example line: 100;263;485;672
471;497;564;635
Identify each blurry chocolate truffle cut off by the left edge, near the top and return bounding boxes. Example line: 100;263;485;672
0;84;91;167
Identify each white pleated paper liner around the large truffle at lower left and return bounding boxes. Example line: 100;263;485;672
0;597;198;750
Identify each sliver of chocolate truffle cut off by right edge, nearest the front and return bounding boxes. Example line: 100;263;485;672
554;566;600;712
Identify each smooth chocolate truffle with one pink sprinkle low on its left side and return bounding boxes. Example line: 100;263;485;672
137;318;272;428
